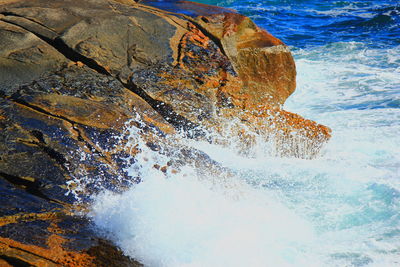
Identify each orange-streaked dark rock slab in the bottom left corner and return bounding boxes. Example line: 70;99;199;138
0;212;142;266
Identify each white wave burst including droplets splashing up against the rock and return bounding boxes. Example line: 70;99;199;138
73;102;319;266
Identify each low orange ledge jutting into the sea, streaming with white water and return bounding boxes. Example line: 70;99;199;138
217;107;331;159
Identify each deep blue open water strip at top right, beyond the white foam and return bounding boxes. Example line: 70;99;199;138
197;0;400;48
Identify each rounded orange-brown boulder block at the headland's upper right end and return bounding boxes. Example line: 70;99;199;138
196;13;296;107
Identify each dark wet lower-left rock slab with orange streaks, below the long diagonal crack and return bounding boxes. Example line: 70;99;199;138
0;67;166;266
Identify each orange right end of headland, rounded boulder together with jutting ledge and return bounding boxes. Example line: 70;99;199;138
138;0;331;158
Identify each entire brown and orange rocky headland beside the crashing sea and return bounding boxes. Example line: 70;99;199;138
0;0;330;266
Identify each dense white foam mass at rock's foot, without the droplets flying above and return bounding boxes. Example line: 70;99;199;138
93;134;322;266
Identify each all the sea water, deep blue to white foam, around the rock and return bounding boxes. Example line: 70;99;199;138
90;0;400;267
